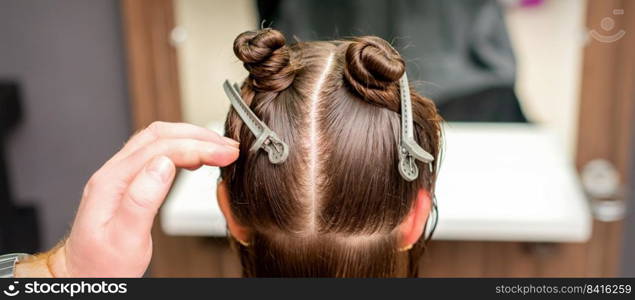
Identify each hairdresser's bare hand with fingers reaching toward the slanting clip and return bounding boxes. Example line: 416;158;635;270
16;122;238;277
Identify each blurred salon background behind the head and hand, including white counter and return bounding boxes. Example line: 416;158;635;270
0;0;635;277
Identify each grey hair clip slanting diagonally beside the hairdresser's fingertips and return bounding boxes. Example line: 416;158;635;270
223;80;289;164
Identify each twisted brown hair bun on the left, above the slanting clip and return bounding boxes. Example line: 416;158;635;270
234;29;294;92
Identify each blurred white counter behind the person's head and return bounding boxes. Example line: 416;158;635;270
161;123;591;242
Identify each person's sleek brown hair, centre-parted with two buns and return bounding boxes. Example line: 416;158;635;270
222;29;441;277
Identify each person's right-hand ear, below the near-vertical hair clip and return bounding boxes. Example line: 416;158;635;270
399;189;432;248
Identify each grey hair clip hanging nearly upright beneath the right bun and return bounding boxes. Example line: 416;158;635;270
399;72;434;181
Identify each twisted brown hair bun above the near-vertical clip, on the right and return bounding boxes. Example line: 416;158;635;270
344;36;406;106
